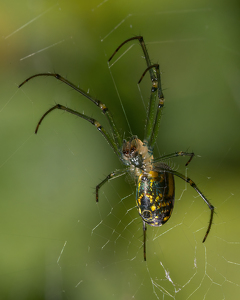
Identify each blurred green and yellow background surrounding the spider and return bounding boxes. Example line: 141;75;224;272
0;0;240;299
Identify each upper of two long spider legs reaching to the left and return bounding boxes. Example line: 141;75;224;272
18;73;122;148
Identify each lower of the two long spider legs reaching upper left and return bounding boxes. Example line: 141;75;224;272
35;104;121;160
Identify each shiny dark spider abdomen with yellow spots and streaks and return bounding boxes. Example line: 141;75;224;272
136;170;175;226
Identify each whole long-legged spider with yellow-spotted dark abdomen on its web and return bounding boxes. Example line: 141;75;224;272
19;36;214;261
